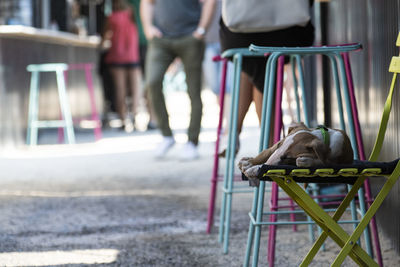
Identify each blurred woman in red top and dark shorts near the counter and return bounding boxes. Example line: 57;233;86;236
102;0;142;131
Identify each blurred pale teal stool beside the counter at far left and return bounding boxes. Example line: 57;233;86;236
26;63;75;145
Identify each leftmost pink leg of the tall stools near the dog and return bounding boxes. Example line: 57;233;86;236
207;60;228;234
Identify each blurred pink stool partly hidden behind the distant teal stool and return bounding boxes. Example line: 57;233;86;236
58;63;102;142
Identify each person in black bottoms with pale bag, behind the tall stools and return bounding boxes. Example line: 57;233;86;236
220;0;314;154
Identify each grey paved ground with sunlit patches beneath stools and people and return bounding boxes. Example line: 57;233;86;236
0;93;400;266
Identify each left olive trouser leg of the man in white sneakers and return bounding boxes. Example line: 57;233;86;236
145;39;175;136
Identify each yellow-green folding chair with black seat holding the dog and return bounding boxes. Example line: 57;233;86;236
241;35;400;266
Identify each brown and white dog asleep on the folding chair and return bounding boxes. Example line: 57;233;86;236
239;123;353;183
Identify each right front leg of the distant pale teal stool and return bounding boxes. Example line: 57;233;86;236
56;70;75;144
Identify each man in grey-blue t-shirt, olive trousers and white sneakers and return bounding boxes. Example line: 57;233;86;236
141;0;215;160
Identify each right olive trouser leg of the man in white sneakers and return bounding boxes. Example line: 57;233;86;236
176;36;204;145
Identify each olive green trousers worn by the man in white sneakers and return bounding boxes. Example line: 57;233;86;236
145;35;204;145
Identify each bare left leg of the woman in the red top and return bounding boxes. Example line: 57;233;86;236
110;67;126;124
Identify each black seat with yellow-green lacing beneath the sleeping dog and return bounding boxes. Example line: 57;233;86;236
242;159;399;184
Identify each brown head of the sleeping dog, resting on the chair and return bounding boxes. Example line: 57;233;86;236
279;132;330;167
